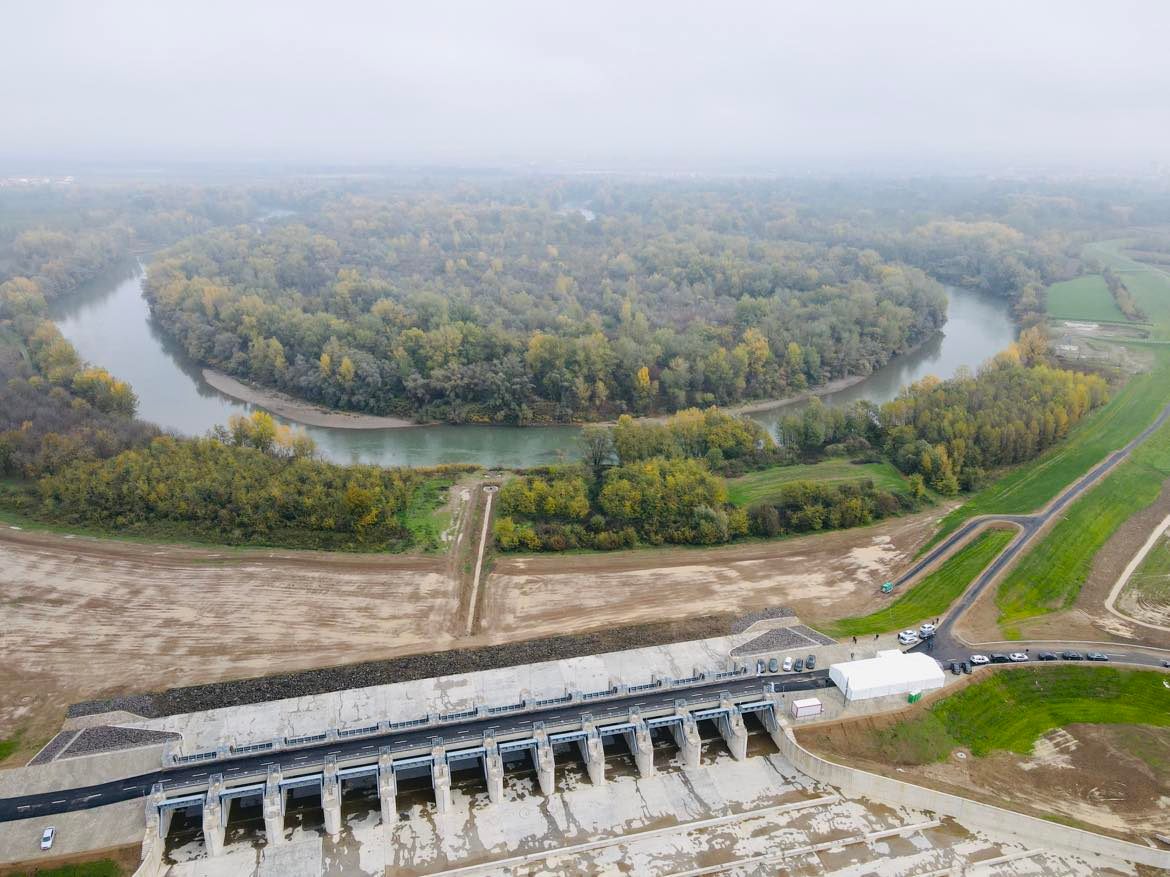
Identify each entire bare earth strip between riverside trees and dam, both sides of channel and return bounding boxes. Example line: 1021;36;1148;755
0;507;947;764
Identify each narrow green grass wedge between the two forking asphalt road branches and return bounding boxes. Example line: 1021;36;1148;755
820;527;1016;638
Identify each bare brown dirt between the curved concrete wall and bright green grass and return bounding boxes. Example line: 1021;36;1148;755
800;717;1170;840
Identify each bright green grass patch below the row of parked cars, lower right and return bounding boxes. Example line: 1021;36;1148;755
873;667;1170;765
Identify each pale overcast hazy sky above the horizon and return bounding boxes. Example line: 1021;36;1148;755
0;0;1170;170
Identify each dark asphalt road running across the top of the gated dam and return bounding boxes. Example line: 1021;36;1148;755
0;670;831;822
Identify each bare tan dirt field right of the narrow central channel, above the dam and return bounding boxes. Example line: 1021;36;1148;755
483;509;947;637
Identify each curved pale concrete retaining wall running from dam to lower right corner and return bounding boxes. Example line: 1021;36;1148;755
773;723;1170;869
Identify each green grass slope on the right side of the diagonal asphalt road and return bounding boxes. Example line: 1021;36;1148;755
996;413;1170;638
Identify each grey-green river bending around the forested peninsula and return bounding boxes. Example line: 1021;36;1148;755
53;267;1016;468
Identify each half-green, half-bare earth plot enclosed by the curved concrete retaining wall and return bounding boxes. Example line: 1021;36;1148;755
797;667;1170;840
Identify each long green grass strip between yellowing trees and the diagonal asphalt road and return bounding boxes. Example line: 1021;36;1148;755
922;345;1170;552
